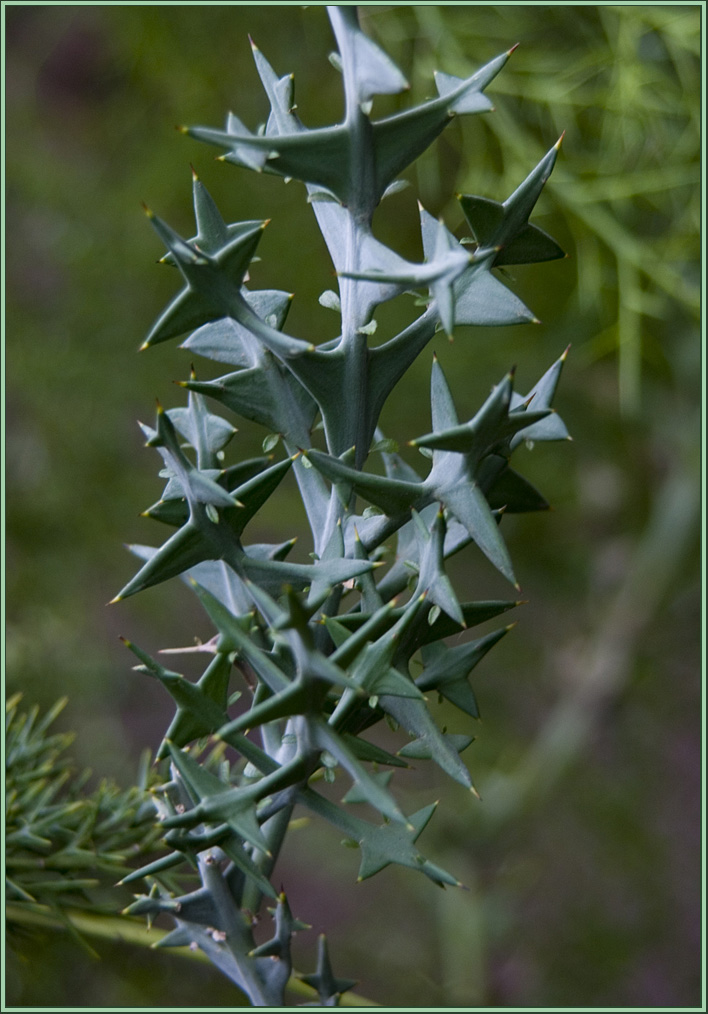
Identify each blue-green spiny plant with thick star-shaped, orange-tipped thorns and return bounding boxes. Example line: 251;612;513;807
117;6;568;1007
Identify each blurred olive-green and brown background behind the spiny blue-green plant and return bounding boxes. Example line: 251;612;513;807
5;4;701;1008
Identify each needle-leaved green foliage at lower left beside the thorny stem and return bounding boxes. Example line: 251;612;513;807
5;695;159;930
